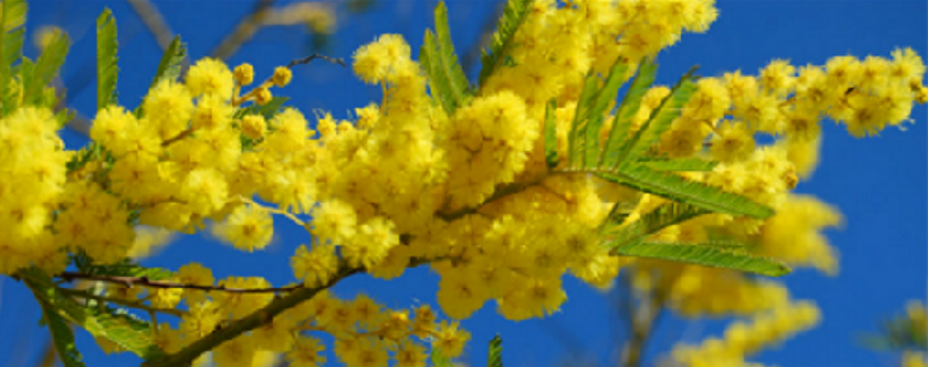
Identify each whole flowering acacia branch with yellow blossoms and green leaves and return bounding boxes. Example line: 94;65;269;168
0;0;928;367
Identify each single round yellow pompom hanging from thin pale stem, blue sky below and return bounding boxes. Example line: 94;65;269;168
213;204;274;252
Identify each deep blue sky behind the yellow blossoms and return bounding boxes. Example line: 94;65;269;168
0;0;928;367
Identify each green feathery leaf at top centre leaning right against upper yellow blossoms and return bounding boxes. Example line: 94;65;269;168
479;0;533;86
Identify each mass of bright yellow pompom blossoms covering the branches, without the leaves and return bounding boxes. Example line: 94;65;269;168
0;0;928;367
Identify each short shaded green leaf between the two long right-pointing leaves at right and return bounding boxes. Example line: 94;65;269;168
605;202;711;247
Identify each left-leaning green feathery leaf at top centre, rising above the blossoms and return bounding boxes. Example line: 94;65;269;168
419;2;471;115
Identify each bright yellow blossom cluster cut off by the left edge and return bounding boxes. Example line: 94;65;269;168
0;108;69;274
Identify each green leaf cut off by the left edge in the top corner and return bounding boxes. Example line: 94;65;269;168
0;0;28;116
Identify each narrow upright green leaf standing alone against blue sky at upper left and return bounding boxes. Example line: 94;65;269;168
97;8;119;111
